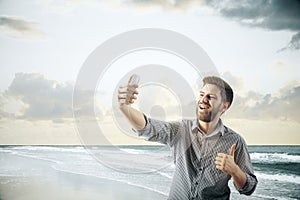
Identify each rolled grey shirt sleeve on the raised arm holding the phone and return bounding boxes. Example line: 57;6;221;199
133;115;180;147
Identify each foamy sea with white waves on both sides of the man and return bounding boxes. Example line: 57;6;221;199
0;145;300;200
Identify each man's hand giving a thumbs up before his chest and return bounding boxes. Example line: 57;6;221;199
215;144;239;176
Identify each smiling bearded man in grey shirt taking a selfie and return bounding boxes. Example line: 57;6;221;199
118;76;257;200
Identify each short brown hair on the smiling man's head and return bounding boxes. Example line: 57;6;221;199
202;76;233;107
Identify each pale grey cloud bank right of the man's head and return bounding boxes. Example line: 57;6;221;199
226;82;300;123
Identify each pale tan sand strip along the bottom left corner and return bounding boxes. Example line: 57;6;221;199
0;175;164;200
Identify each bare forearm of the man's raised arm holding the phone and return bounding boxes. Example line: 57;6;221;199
119;104;146;130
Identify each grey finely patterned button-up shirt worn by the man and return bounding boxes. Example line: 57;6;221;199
136;116;257;200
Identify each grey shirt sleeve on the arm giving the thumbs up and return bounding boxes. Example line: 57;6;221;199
234;139;258;195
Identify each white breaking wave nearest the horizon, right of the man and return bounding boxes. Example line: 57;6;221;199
250;153;300;163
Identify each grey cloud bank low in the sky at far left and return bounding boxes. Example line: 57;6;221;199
0;73;103;119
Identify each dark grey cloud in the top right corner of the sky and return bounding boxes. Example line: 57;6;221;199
206;0;300;50
